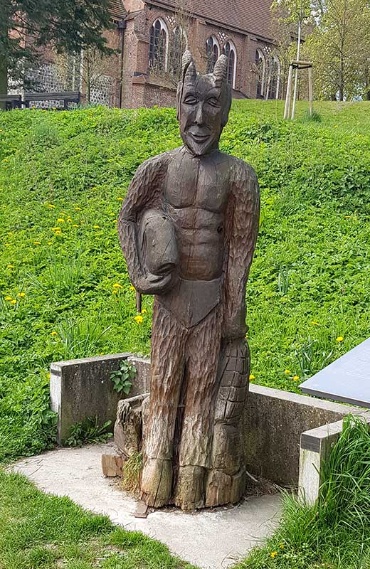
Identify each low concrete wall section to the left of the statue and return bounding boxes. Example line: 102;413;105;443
50;353;149;445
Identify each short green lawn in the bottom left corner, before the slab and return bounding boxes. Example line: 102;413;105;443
0;469;195;569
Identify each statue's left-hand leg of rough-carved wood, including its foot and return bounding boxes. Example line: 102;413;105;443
141;302;186;508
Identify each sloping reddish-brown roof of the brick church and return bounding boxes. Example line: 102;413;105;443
146;0;272;39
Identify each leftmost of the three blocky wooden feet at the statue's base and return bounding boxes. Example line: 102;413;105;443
141;458;172;508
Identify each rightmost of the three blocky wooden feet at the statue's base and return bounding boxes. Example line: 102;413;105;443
205;470;245;508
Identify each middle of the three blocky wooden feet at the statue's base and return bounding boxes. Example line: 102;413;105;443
174;466;206;510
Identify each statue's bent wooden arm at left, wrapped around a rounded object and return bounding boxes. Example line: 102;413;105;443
118;154;171;294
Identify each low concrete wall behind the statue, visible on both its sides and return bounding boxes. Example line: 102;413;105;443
50;354;363;487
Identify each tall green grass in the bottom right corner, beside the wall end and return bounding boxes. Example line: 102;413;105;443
235;417;370;569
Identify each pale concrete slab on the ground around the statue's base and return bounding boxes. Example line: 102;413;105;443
12;444;281;569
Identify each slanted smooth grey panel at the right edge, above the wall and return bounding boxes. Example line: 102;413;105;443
300;338;370;408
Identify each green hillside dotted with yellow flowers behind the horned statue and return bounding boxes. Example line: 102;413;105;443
0;101;370;460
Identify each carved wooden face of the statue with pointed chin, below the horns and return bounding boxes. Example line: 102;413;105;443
179;75;225;156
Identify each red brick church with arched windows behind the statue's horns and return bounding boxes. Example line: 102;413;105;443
21;0;281;108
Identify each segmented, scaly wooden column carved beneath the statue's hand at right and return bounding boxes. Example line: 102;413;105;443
206;339;250;507
